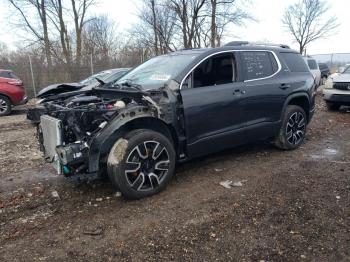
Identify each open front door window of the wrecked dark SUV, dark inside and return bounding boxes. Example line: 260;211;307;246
193;53;237;88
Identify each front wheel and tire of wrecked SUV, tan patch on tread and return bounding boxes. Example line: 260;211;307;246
107;129;176;199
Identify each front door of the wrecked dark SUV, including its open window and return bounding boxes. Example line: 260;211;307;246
181;52;246;157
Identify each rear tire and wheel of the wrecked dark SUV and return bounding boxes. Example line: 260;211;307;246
275;105;307;150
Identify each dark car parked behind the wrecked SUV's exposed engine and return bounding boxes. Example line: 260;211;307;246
37;68;130;98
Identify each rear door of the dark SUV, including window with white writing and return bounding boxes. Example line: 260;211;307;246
240;51;290;140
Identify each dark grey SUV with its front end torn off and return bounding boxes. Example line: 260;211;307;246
38;42;315;199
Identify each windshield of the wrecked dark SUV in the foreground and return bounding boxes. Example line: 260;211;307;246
117;53;198;90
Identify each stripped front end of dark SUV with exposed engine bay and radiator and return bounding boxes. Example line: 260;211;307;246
38;88;180;176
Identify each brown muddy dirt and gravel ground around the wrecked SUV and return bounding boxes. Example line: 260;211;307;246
0;95;350;261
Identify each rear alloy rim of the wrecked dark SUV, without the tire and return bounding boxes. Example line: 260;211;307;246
286;112;306;145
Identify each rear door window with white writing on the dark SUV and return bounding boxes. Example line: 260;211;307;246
242;51;278;80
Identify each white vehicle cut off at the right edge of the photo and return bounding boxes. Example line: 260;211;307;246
322;66;350;110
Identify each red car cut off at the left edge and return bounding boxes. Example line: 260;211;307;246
0;69;28;116
